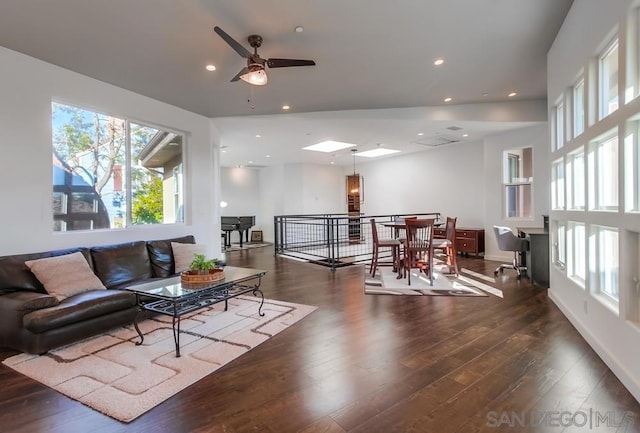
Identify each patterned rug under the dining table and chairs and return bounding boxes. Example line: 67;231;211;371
364;266;494;296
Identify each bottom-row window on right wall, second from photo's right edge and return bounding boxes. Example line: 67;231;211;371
589;226;620;305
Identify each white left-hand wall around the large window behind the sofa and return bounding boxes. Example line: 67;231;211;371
0;47;220;255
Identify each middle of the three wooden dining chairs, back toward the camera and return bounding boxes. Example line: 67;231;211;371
403;219;435;286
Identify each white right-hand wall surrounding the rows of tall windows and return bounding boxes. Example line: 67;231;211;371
547;0;640;401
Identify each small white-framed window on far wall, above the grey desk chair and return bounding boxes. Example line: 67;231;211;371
503;147;533;218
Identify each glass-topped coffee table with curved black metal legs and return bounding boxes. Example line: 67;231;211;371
124;266;267;357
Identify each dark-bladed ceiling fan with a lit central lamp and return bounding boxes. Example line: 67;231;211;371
213;26;316;86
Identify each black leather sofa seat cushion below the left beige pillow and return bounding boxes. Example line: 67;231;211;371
23;290;136;333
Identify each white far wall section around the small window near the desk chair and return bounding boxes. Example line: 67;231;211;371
483;122;550;262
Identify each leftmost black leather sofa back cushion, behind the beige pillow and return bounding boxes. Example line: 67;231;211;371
0;248;91;294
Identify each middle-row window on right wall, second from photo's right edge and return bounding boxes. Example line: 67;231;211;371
588;130;618;211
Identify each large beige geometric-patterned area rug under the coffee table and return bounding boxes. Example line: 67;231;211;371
3;297;316;422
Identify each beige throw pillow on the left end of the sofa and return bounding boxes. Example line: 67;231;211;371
24;252;106;301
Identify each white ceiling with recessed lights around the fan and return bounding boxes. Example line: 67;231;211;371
0;0;572;166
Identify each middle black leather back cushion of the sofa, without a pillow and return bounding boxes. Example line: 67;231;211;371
91;241;151;288
